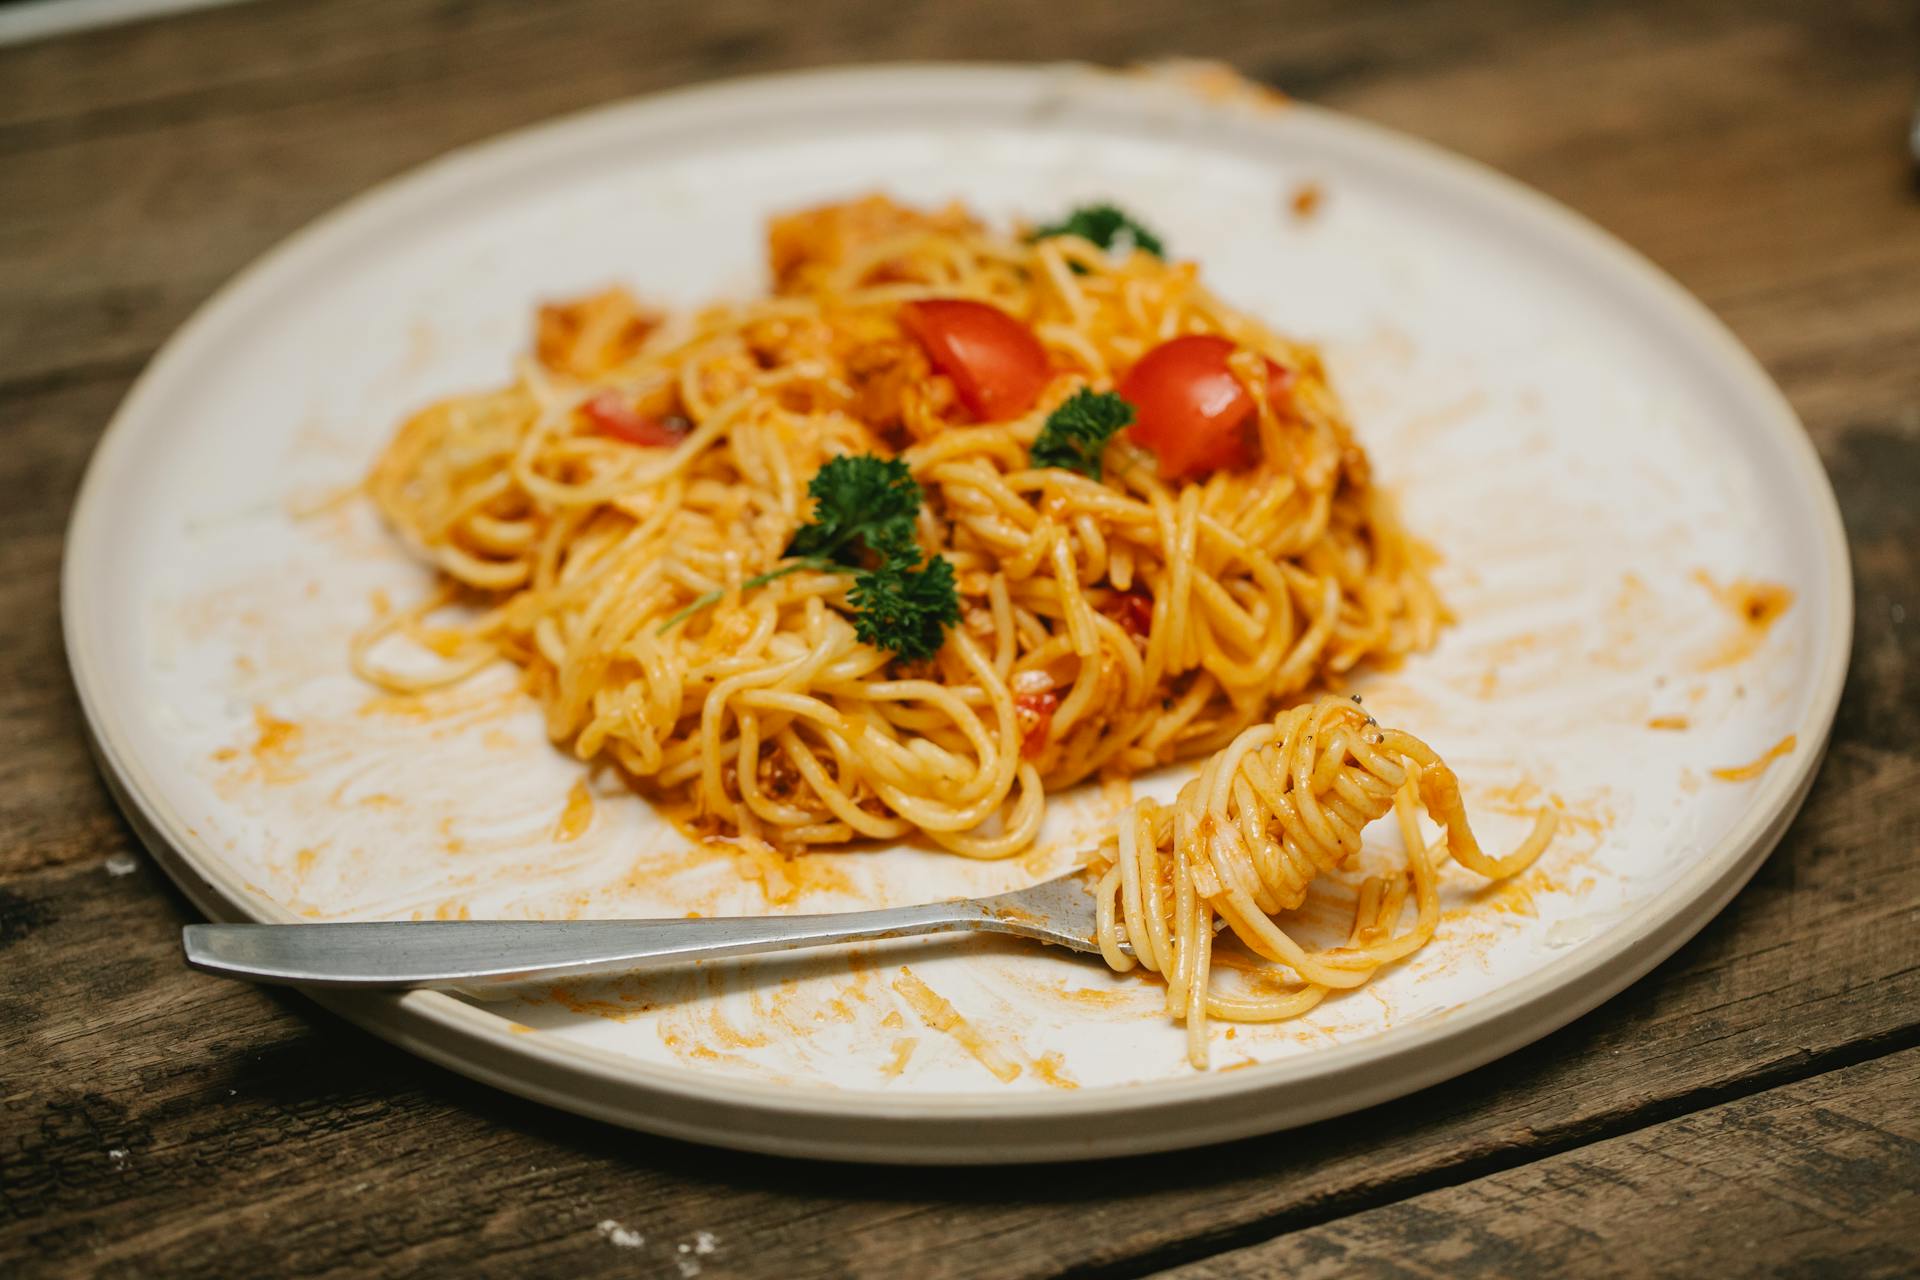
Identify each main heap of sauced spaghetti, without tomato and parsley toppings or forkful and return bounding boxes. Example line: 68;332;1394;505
355;198;1444;858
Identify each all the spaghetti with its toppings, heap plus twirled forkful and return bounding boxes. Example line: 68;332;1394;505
353;196;1551;1063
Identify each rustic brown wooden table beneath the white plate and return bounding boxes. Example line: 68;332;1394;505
0;0;1920;1278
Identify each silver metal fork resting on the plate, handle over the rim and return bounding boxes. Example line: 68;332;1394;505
180;871;1100;988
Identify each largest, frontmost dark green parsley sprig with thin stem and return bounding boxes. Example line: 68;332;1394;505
660;455;960;658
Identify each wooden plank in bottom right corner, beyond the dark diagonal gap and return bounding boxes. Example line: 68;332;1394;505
1162;1050;1920;1280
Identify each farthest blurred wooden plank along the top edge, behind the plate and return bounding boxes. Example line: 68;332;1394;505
0;0;1574;132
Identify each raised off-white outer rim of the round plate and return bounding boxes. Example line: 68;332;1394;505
61;61;1853;1163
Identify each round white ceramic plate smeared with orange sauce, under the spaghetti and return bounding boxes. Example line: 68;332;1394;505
65;67;1851;1161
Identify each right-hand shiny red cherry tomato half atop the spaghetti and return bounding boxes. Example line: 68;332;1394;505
1119;334;1292;480
